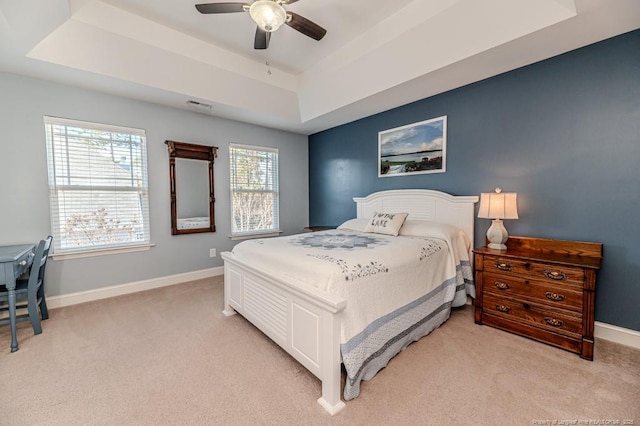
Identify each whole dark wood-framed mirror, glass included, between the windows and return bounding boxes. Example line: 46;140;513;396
165;141;218;235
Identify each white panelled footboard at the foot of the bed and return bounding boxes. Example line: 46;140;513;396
221;252;347;415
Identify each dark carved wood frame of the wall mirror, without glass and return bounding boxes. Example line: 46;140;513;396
164;140;218;235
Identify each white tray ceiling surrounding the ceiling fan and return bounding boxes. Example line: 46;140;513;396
0;0;640;134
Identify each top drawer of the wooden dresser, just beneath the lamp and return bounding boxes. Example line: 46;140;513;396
484;256;584;287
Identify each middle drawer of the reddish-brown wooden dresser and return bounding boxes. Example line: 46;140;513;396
483;273;583;313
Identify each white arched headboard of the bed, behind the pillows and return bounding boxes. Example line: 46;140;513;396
353;189;478;253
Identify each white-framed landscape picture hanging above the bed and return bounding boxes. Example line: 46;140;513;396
378;115;447;177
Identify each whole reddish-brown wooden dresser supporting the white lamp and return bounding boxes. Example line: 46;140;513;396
474;237;602;360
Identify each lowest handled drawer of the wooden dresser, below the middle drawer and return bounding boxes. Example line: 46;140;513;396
483;293;582;337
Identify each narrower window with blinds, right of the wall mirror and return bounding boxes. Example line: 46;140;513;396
229;144;280;237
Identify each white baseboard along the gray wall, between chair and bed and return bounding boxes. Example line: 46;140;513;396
47;266;224;309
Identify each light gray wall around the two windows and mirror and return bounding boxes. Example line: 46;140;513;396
0;73;309;295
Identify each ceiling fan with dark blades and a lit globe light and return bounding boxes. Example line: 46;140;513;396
196;0;327;49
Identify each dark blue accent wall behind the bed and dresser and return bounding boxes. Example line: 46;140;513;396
309;30;640;331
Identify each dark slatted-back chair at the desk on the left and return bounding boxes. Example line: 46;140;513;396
0;235;53;334
